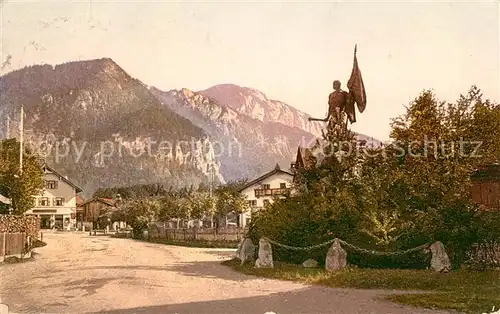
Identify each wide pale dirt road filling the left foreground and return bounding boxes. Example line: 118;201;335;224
0;232;454;314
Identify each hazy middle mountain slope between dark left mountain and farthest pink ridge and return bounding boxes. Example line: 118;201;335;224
150;87;314;180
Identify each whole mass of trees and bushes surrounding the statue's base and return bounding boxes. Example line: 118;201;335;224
250;87;500;267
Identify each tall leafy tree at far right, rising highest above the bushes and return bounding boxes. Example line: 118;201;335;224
384;87;500;266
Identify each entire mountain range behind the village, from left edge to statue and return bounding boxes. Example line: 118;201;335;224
0;58;378;197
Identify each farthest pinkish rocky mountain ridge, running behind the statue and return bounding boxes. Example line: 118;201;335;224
198;84;381;146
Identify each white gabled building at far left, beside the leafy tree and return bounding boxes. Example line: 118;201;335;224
26;165;82;230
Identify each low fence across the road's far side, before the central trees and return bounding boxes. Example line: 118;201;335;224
149;224;245;242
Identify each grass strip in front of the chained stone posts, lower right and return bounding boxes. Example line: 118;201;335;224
222;259;500;313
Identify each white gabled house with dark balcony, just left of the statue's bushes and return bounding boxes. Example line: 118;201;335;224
239;164;293;227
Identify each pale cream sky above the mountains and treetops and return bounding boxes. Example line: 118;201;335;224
0;0;500;140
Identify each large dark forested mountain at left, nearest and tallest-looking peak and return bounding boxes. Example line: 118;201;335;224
0;59;223;195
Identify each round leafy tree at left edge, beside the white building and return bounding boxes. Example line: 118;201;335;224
0;139;44;214
